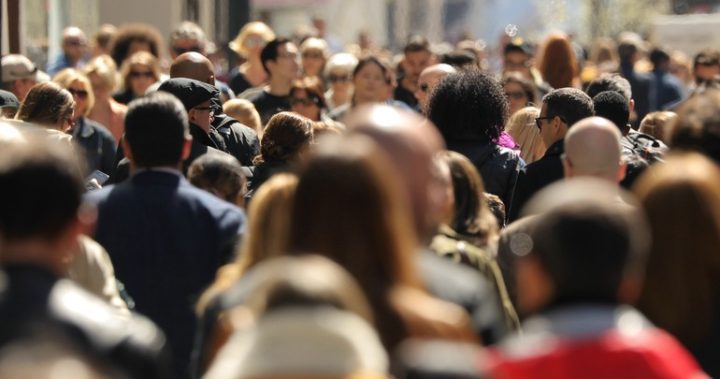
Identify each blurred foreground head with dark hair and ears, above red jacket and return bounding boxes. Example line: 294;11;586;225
516;178;649;314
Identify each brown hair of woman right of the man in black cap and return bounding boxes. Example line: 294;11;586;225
253;112;313;165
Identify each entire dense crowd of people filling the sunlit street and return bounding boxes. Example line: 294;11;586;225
0;20;720;379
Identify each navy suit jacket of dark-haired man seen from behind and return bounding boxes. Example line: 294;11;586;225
87;170;245;378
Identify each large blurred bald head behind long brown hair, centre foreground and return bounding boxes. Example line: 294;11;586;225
346;105;445;241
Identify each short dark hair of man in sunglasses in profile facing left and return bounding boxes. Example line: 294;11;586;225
543;88;595;127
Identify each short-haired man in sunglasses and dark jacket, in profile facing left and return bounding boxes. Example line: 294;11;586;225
510;88;595;221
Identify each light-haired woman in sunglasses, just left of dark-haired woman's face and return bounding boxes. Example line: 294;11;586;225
323;53;358;112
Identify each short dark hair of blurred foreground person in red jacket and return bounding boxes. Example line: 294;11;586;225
531;201;647;302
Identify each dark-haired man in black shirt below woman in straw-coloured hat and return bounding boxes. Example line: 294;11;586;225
248;38;300;125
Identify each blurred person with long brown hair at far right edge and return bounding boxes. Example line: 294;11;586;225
633;153;720;377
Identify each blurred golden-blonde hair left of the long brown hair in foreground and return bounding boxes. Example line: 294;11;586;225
198;173;297;314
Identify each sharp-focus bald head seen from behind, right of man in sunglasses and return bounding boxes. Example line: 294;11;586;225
563;117;625;182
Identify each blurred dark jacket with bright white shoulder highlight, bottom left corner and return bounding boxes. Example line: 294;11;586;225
0;264;173;379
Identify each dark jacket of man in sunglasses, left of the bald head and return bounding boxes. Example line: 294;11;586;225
508;140;565;221
